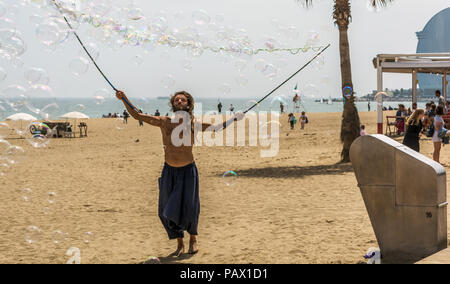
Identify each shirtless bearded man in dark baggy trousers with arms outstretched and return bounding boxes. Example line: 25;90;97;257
116;91;244;256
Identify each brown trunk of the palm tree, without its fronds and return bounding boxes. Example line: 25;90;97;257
338;21;360;162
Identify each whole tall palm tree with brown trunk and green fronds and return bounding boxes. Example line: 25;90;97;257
297;0;393;162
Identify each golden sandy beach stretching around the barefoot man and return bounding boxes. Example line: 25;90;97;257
0;112;450;264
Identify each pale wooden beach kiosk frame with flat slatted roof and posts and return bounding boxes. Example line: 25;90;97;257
373;53;450;134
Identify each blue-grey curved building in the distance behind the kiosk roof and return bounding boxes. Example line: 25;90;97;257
416;8;450;93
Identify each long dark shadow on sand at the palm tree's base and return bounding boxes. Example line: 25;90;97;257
232;163;353;178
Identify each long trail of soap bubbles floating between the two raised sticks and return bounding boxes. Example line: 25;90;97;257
33;0;321;93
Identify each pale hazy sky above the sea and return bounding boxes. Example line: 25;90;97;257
0;0;450;98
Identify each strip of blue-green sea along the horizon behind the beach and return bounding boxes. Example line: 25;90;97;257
0;97;426;119
